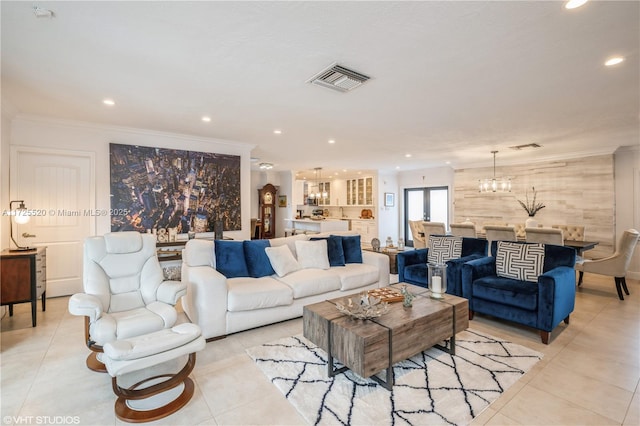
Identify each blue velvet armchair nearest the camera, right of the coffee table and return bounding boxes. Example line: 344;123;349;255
461;241;576;344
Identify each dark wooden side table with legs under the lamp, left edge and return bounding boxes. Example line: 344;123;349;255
0;247;47;327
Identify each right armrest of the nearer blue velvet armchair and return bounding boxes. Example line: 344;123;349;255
537;266;576;331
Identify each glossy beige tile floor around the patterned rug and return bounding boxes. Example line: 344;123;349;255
0;274;640;425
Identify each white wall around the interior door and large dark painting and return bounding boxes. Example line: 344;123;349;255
2;116;253;243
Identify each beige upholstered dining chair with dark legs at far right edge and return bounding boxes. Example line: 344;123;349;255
576;229;640;300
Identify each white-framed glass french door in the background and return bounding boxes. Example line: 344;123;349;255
404;186;449;247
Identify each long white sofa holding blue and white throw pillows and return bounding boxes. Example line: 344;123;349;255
182;233;389;339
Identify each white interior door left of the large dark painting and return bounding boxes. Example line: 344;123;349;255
10;147;96;297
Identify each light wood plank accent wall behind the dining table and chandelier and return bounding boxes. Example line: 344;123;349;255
453;154;616;258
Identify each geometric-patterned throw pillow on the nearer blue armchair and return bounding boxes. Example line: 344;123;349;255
496;241;544;282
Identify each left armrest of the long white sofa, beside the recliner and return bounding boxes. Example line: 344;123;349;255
182;262;228;339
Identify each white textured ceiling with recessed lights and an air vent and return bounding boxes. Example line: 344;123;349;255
0;1;640;174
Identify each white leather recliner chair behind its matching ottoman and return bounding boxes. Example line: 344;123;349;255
69;232;187;372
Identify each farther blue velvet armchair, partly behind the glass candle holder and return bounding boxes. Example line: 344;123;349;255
397;238;488;296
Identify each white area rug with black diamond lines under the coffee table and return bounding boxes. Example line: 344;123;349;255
247;330;542;425
